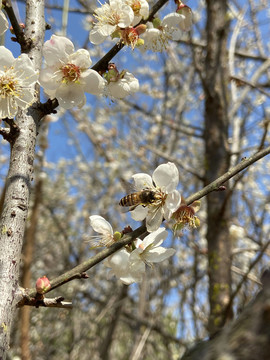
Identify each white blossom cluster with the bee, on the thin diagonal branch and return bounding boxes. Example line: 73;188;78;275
90;162;200;284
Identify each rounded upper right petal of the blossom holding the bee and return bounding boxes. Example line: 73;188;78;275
153;162;179;193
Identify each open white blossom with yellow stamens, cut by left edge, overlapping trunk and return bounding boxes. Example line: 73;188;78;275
0;46;38;119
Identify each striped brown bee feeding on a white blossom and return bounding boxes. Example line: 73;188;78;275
119;189;160;211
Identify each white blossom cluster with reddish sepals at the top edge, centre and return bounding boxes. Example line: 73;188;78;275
89;0;192;52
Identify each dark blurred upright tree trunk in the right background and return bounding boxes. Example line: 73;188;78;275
203;0;231;334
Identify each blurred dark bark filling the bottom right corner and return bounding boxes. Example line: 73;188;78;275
181;275;270;360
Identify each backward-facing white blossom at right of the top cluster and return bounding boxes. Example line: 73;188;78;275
140;13;184;52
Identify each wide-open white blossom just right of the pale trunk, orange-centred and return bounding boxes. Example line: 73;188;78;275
39;35;105;109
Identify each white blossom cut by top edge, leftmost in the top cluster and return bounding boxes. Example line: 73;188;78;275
89;0;134;45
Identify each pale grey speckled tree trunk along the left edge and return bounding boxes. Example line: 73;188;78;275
0;0;45;360
